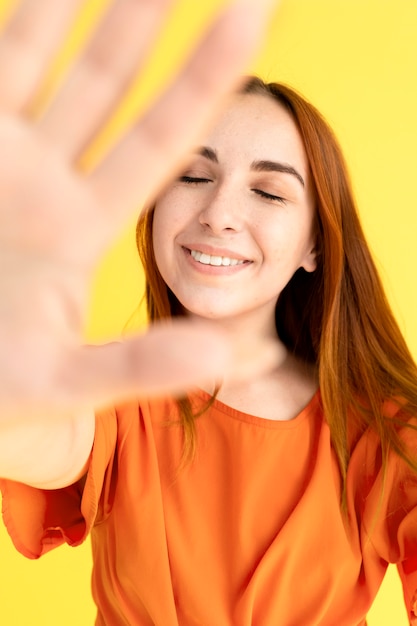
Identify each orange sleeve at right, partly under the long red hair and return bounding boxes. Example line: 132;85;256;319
348;399;417;626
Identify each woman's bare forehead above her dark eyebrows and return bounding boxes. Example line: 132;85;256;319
205;94;309;174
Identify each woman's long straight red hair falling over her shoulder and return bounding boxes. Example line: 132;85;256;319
137;77;417;498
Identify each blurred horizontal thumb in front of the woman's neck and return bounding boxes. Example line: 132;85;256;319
59;320;233;405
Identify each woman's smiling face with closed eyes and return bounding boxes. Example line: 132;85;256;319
153;94;316;326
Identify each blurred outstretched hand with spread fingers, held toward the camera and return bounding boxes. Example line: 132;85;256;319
0;0;280;415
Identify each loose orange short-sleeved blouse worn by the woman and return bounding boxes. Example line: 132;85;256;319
2;392;417;626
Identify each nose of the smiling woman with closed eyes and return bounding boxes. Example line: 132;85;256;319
199;185;243;234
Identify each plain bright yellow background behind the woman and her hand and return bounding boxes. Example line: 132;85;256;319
0;0;417;626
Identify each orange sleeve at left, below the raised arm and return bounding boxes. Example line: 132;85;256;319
0;409;117;559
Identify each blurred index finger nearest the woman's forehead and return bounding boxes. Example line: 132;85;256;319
90;0;278;229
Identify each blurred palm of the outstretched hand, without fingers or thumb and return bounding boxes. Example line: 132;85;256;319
0;116;96;410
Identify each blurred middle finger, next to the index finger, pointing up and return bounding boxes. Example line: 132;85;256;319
38;0;172;158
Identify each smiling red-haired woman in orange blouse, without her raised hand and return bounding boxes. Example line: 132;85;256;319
3;72;417;626
